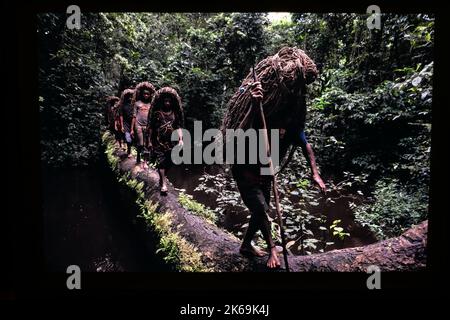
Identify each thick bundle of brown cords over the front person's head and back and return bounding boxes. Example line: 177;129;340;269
222;47;318;130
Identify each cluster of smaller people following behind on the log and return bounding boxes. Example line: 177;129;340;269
105;82;184;193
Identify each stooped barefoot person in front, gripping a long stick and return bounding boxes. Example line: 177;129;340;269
222;47;325;268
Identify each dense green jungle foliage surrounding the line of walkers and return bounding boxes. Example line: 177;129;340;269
37;13;434;244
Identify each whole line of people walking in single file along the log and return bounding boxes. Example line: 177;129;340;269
103;47;326;268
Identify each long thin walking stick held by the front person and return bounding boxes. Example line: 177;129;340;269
252;65;290;272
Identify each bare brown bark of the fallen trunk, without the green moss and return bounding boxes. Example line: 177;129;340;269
106;136;428;272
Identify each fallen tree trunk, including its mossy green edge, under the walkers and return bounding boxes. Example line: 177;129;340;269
103;133;428;272
